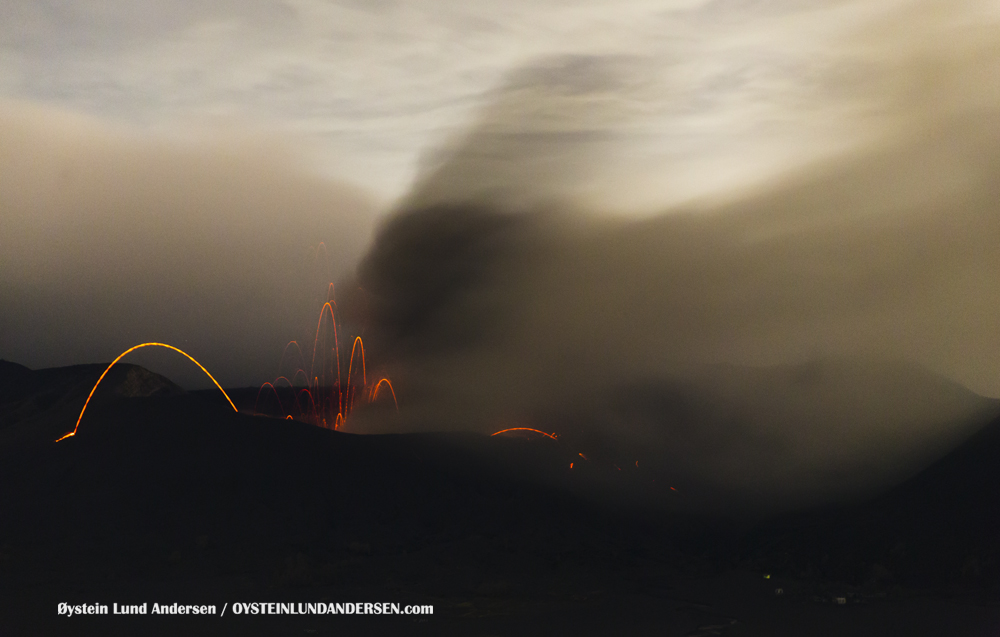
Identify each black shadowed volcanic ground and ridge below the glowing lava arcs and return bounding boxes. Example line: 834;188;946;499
0;364;1000;637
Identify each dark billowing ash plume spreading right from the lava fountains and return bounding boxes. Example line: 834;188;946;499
350;3;1000;507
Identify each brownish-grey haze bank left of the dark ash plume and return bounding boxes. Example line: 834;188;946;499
0;102;375;386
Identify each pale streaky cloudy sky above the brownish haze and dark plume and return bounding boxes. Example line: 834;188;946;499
0;0;894;207
